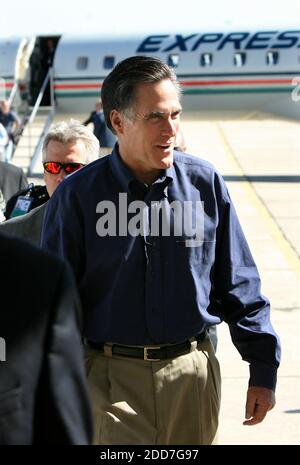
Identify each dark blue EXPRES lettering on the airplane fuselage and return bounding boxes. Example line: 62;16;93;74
137;30;300;53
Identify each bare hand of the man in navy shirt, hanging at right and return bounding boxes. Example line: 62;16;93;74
243;386;275;426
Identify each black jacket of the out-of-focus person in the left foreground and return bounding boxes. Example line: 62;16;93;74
0;235;92;444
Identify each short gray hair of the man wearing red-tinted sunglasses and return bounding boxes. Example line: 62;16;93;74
42;119;100;164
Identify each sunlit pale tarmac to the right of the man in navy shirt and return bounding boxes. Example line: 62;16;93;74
182;110;300;445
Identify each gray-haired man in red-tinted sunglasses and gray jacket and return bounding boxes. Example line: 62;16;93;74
0;120;99;245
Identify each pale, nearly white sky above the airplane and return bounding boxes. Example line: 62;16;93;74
0;0;300;37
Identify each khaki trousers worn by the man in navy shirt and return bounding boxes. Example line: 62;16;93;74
85;338;221;445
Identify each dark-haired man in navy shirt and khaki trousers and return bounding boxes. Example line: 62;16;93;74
42;56;280;444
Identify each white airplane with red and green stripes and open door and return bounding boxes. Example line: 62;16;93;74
0;29;300;118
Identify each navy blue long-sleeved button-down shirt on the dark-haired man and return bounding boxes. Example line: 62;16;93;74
42;145;280;388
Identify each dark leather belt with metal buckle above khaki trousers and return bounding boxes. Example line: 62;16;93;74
84;331;206;361
